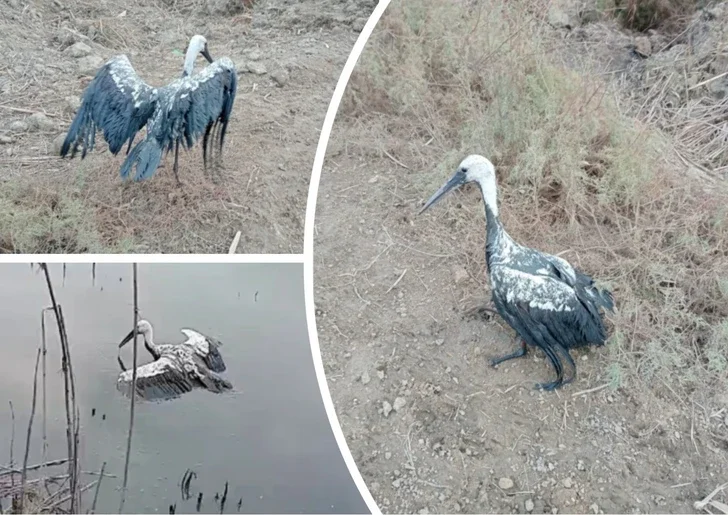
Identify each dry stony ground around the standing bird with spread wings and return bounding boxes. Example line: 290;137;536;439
0;0;374;253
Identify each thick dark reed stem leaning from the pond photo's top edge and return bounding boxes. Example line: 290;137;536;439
40;263;78;513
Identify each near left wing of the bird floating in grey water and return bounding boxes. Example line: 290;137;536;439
116;356;195;400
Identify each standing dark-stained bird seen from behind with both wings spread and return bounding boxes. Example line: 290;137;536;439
61;35;238;184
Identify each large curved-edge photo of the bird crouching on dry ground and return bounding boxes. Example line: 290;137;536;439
313;0;728;514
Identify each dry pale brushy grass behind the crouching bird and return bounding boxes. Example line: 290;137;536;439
340;0;728;398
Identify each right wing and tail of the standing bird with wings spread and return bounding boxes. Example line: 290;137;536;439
121;58;238;181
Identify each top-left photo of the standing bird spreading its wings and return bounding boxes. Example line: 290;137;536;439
0;0;376;254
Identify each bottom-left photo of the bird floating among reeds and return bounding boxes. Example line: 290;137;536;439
0;264;369;513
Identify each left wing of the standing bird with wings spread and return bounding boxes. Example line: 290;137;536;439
61;55;157;158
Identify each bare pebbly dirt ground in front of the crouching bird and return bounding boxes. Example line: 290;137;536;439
314;2;728;513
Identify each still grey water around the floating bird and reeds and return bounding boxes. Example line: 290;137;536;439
0;264;366;513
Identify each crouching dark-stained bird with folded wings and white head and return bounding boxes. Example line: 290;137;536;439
420;155;614;390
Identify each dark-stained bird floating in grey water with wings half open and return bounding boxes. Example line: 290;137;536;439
116;320;233;400
